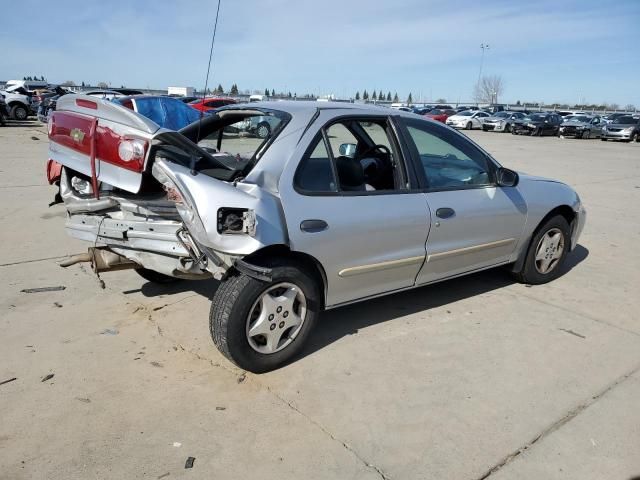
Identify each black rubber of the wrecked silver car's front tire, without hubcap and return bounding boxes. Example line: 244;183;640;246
514;215;571;285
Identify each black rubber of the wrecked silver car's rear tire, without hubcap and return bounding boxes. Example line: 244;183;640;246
209;258;321;373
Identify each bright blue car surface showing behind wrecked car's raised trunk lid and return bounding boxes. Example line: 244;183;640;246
112;95;204;130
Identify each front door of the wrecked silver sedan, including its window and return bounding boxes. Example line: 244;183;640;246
405;119;526;284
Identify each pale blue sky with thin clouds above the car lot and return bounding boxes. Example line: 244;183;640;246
0;0;640;107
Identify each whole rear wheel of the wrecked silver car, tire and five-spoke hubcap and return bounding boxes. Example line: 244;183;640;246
209;258;320;373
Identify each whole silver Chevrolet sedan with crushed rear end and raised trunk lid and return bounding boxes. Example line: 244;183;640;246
48;95;586;372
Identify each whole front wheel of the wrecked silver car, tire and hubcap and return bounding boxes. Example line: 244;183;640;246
515;215;571;285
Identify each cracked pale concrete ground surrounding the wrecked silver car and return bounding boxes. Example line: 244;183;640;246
0;122;640;480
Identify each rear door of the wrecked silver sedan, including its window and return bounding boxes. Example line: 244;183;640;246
280;111;430;307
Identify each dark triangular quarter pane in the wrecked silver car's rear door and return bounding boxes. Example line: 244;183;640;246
294;135;337;192
